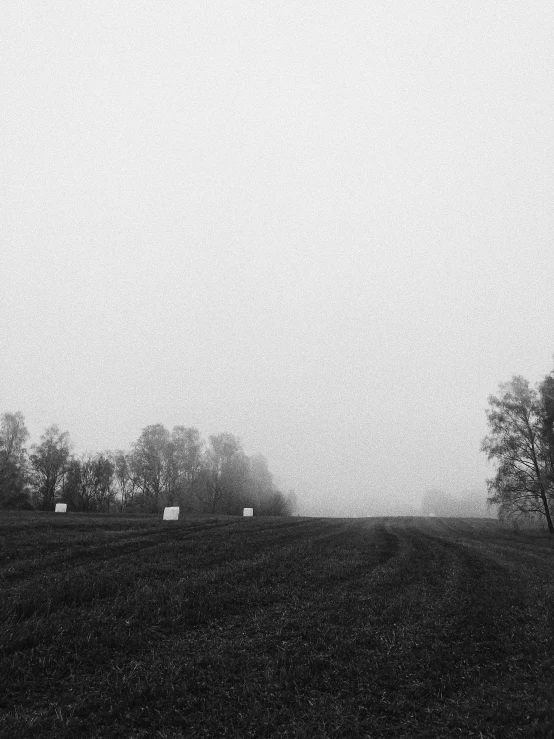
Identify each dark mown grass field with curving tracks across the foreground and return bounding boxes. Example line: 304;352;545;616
0;512;554;739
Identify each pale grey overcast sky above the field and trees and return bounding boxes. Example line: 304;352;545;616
0;0;554;516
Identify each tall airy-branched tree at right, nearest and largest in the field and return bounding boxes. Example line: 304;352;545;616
481;376;554;533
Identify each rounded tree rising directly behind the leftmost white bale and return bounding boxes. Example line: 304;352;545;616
29;425;71;511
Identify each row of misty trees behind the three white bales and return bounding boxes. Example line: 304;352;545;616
0;420;296;516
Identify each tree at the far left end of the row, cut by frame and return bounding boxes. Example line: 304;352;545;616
0;411;31;508
